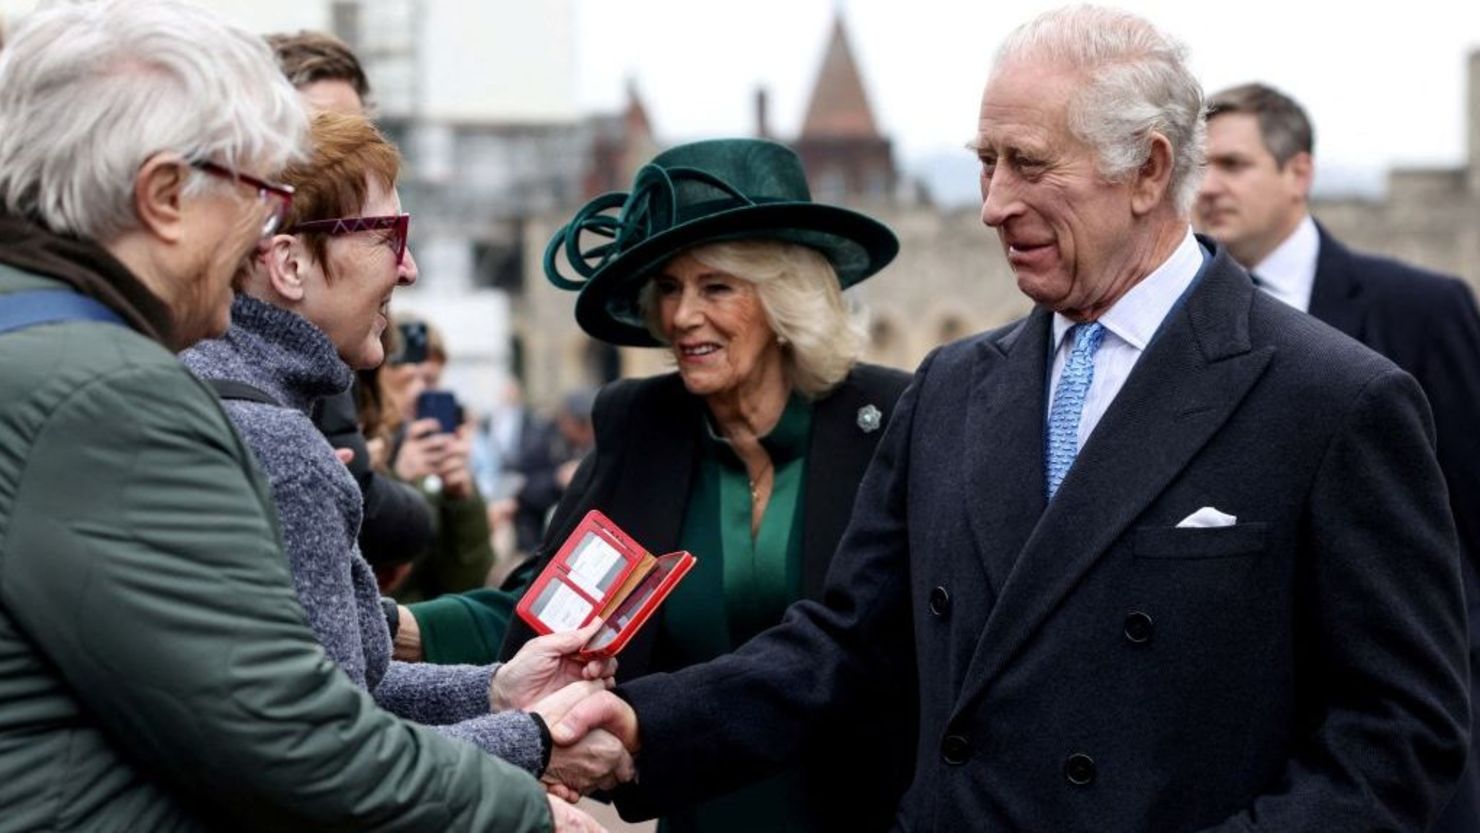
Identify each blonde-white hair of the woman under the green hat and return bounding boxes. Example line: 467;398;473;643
639;240;867;398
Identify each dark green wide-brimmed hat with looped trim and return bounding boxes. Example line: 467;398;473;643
545;139;900;346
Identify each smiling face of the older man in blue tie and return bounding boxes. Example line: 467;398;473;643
975;59;1141;318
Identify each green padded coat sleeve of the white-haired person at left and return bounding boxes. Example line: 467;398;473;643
0;367;551;832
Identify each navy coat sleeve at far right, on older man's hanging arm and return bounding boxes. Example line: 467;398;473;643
1214;370;1470;833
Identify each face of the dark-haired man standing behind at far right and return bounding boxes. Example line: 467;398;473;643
1197;112;1311;266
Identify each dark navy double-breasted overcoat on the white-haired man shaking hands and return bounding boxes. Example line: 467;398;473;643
617;252;1468;833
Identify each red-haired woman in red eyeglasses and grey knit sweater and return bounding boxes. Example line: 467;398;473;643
182;112;630;804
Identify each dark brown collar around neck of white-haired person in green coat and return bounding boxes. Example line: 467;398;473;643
0;213;175;349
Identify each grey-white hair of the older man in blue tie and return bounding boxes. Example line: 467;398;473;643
993;6;1208;216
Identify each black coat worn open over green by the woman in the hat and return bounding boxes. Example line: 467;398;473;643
505;364;915;833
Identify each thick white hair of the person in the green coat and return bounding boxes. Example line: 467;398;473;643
0;0;308;243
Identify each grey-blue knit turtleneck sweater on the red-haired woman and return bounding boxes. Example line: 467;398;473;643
181;296;542;775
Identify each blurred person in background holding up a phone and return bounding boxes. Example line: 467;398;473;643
380;315;494;604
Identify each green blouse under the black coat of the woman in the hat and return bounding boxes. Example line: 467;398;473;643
660;395;813;833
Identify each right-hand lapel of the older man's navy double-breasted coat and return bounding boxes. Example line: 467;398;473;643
958;252;1273;710
